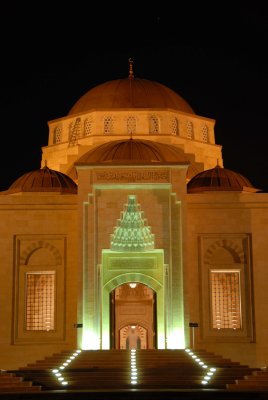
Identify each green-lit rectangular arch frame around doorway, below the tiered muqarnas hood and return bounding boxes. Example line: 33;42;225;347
101;258;166;349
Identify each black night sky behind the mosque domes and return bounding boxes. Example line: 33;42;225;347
0;0;268;192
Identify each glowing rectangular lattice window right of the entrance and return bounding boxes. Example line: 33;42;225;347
210;270;242;330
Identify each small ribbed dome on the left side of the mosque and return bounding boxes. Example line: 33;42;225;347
6;167;77;194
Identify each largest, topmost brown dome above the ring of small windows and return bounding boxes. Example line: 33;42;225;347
69;77;194;115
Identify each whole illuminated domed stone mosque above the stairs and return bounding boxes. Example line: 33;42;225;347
0;60;268;369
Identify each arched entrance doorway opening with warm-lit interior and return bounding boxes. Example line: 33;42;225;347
110;282;156;349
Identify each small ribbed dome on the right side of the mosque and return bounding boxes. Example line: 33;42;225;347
187;165;260;193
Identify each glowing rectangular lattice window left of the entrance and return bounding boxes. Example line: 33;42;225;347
26;272;55;331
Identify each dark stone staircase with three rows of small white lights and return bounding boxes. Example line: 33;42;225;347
1;350;262;392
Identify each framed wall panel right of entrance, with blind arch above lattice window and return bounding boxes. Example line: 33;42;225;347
200;234;253;340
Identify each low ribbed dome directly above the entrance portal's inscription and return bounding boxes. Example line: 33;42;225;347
75;139;190;165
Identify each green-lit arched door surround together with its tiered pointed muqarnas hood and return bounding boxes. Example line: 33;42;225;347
101;195;165;349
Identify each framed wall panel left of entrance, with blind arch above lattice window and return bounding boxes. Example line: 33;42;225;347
14;235;65;343
